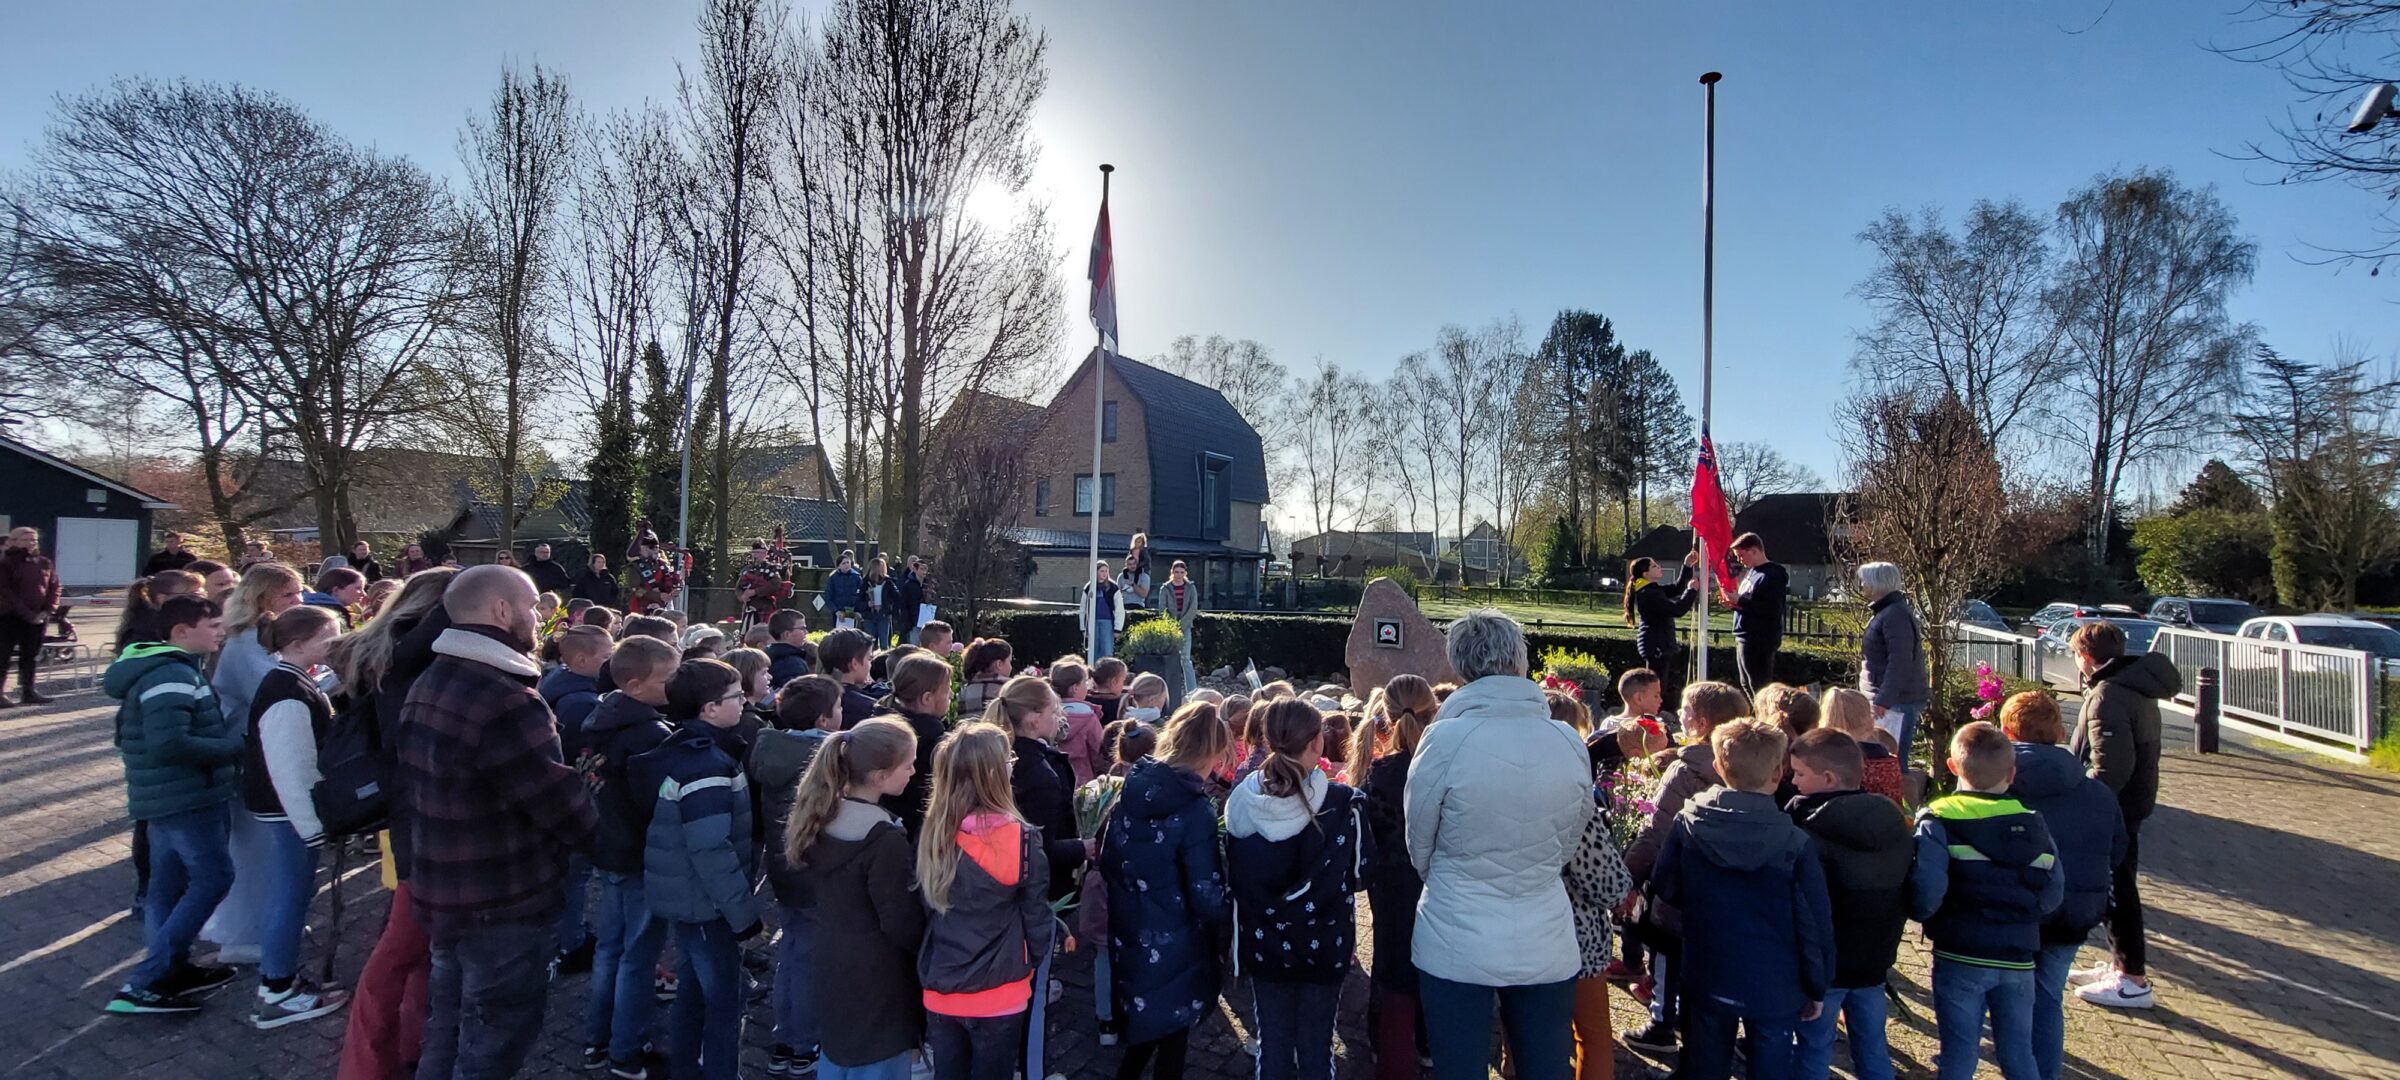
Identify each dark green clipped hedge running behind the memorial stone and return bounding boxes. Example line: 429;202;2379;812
955;610;1858;703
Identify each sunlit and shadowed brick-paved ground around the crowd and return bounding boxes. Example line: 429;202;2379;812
0;667;2400;1080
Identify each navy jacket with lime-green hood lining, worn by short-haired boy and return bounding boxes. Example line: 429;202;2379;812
1908;792;2066;972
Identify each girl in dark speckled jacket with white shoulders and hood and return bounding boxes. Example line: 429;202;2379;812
1224;698;1368;1080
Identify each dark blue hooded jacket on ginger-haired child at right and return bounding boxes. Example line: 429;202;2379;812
2009;742;2126;946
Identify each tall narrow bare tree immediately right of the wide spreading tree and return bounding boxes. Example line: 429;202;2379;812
432;65;581;550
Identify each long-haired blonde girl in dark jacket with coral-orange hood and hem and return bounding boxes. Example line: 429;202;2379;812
917;715;1056;1080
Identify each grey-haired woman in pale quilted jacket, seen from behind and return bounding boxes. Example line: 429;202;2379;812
1404;607;1594;1080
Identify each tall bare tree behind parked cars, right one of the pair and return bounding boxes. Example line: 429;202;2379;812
2050;173;2258;564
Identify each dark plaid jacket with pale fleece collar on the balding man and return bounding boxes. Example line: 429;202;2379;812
401;626;595;941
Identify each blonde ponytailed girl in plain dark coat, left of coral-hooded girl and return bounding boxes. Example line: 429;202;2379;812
778;718;924;1080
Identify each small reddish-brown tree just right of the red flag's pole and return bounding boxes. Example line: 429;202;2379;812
1836;391;2011;782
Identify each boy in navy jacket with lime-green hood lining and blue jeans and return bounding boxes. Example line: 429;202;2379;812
1908;722;2066;1080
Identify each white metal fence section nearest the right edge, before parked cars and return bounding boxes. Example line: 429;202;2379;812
2150;629;2386;754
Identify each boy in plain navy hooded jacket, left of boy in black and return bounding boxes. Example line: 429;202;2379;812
1651;720;1834;1080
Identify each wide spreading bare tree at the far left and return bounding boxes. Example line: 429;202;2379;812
19;79;461;547
